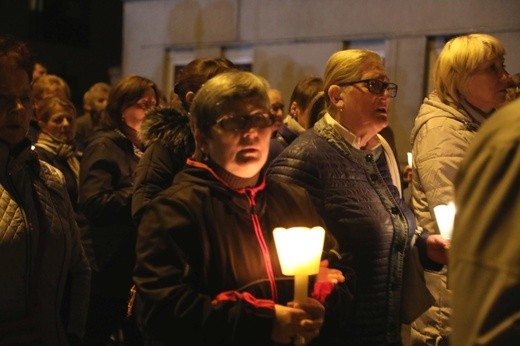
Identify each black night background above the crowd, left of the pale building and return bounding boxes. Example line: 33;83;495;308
0;0;123;111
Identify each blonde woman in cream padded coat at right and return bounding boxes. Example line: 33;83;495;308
410;34;511;345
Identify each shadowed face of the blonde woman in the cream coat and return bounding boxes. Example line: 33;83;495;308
461;58;511;113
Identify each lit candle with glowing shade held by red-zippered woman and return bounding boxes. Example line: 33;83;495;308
273;227;325;345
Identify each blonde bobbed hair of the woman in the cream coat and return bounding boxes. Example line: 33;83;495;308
434;34;506;104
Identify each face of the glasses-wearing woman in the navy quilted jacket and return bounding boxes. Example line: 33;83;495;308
337;65;390;136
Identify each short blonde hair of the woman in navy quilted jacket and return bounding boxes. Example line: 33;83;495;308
323;49;384;113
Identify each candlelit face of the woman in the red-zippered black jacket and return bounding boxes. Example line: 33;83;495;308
197;98;273;178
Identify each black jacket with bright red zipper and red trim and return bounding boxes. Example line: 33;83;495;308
134;160;351;346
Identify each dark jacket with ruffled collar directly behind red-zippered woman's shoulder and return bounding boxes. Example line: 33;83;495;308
132;108;195;222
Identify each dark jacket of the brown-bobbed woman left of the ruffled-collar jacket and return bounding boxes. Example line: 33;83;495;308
80;130;140;296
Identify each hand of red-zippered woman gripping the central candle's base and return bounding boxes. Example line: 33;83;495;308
271;298;325;344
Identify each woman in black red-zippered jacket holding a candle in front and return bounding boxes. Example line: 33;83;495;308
134;71;349;346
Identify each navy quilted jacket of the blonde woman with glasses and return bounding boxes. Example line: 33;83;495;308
268;116;415;345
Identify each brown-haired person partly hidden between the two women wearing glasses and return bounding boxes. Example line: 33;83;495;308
267;76;323;163
